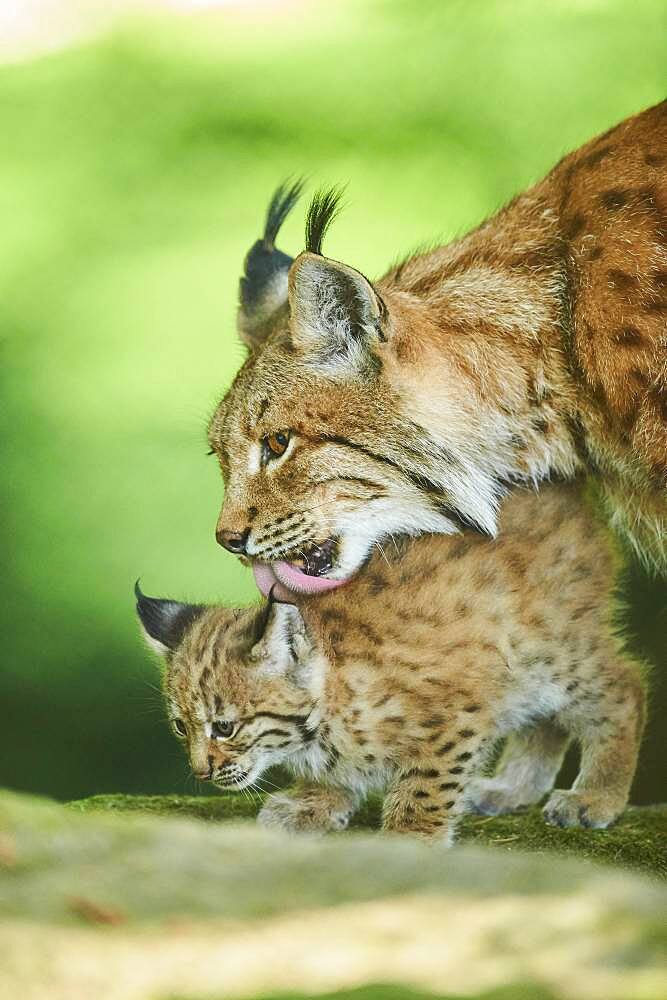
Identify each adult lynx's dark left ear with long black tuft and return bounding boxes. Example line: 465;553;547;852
237;180;303;350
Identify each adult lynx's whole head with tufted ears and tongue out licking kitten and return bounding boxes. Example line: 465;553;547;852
209;185;498;596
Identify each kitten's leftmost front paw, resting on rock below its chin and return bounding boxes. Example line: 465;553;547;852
257;783;357;833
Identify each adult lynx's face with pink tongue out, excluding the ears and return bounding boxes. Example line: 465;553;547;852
209;324;479;593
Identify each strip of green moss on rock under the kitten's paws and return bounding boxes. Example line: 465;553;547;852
69;794;667;878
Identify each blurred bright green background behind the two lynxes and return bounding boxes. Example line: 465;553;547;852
0;0;667;802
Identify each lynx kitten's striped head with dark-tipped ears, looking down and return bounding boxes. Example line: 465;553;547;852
136;586;318;789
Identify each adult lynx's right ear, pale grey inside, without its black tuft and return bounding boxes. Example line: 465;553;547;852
289;252;387;376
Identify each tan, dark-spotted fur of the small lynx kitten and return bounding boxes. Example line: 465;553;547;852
157;485;644;840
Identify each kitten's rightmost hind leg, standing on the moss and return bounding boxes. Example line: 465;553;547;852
544;659;645;827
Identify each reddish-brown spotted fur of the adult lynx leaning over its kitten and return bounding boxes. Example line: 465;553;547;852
209;102;667;579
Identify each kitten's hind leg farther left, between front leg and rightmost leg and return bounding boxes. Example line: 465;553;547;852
466;719;570;816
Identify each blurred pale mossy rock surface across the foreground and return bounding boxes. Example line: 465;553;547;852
0;792;667;1000
